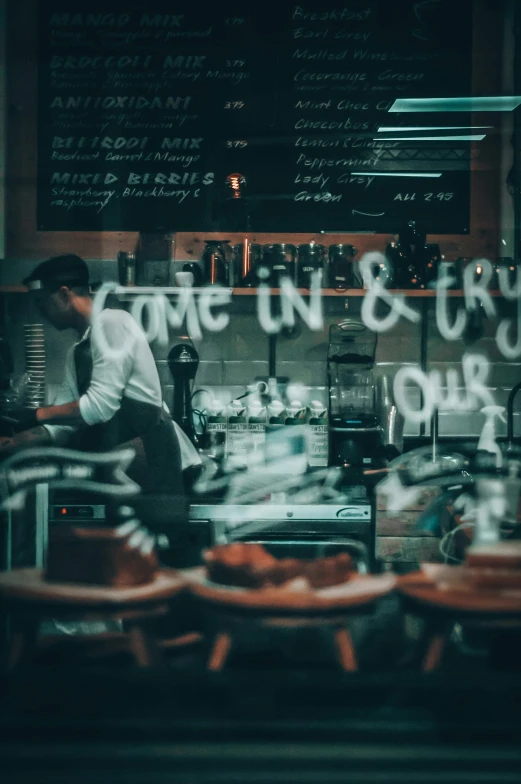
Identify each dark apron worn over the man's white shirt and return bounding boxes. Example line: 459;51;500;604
72;337;184;496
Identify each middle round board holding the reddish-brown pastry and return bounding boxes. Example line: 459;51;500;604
181;567;396;613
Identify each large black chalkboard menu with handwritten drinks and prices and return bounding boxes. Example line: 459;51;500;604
37;0;472;233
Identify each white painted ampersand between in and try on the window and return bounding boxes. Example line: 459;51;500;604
360;252;421;332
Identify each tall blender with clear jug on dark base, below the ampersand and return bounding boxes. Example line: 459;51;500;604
327;319;383;469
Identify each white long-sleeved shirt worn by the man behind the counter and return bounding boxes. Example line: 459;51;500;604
44;309;201;469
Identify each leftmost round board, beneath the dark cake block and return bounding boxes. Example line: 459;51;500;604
0;569;186;607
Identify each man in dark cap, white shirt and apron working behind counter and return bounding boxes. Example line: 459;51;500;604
0;254;200;495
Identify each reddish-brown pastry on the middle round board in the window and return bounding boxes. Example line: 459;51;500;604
204;542;355;588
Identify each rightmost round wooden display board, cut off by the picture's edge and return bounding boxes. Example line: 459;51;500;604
396;564;521;615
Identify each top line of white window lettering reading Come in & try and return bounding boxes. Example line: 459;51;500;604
93;252;521;360
